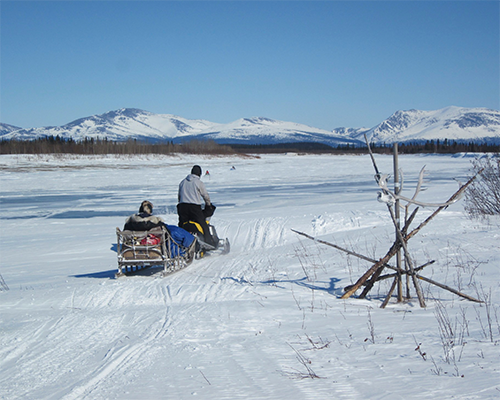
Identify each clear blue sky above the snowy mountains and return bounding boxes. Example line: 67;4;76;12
0;0;500;130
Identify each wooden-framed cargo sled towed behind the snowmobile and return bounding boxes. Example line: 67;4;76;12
115;227;196;278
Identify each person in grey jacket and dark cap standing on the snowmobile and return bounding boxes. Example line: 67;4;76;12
177;165;215;245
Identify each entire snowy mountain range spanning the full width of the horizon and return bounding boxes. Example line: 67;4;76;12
0;107;500;146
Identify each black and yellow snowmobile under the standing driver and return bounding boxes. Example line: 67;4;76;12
182;204;231;258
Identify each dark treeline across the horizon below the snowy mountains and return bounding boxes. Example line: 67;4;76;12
0;136;500;155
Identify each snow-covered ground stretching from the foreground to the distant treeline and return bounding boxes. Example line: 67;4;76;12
0;155;500;400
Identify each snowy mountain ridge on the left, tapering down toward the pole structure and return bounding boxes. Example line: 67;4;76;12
0;108;358;146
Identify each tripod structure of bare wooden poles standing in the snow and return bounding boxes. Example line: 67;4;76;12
292;141;482;308
